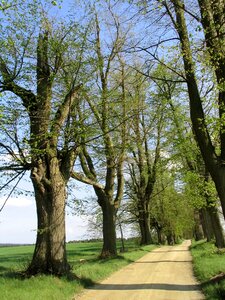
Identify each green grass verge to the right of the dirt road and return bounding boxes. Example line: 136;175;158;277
191;241;225;300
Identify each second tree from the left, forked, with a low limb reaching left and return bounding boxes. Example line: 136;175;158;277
72;6;127;258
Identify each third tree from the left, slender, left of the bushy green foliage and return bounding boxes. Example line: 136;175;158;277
127;73;164;245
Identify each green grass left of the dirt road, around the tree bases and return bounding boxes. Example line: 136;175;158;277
0;241;155;300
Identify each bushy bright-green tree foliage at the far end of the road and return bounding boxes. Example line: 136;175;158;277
150;162;195;245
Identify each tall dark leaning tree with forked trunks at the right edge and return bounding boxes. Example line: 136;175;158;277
126;0;225;246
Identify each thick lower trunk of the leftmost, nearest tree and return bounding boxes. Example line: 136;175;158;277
27;158;69;276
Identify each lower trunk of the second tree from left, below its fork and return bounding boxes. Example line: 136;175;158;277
98;195;117;258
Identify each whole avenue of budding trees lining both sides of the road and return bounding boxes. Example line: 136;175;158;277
0;0;225;275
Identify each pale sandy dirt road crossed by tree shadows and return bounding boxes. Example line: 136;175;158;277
74;241;205;300
